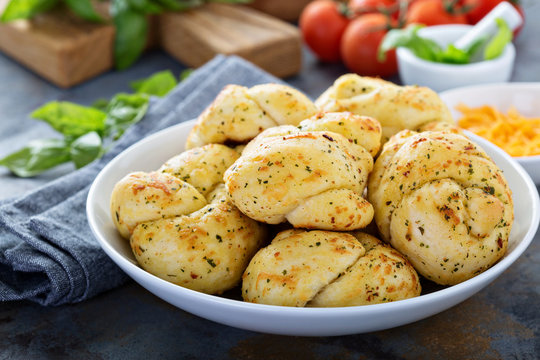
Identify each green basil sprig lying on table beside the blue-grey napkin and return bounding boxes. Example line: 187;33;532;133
0;70;188;177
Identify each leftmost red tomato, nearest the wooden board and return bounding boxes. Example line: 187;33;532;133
300;0;349;62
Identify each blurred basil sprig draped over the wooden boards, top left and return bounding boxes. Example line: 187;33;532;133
0;0;252;70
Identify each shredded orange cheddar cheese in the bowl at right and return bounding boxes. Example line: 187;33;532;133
456;104;540;156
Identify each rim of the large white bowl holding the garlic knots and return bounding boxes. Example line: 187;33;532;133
86;120;540;319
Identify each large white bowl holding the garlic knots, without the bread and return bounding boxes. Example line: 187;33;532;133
86;121;540;336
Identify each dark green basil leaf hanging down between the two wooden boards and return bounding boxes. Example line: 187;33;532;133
111;0;148;70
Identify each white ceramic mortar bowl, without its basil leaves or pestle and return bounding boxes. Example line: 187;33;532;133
396;25;516;92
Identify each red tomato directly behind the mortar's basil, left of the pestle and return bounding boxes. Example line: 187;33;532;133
407;0;468;26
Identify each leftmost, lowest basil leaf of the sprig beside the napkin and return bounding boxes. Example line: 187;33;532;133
0;139;70;177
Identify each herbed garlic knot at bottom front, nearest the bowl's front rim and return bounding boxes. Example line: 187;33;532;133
242;229;421;307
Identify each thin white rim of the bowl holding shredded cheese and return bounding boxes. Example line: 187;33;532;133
439;81;540;165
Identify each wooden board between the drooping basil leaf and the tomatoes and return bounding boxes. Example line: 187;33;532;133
159;3;302;77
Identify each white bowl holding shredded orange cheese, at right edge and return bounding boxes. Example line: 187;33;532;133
439;83;540;185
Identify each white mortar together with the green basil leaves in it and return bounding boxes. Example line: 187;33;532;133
388;25;516;91
